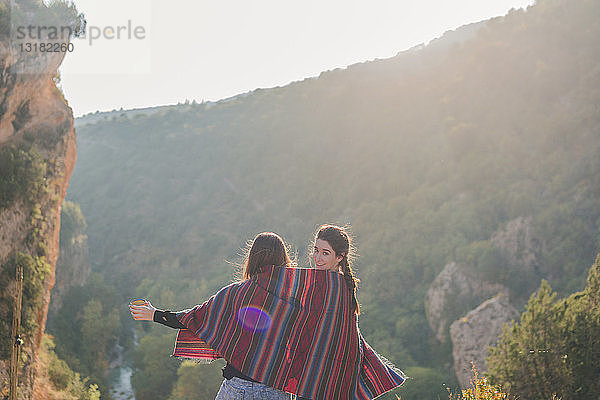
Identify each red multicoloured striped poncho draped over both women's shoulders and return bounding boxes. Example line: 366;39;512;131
173;267;405;400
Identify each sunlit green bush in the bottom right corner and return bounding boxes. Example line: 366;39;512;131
487;255;600;400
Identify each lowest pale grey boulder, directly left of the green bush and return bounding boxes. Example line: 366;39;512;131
450;294;519;388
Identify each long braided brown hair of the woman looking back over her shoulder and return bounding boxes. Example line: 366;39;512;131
313;224;360;315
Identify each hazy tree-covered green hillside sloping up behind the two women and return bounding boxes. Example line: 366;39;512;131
51;0;600;400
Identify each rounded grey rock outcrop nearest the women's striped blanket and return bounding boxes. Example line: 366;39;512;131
425;262;508;343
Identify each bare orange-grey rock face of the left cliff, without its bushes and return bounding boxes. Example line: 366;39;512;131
0;28;76;399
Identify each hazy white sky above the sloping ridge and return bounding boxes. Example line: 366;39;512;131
60;0;533;116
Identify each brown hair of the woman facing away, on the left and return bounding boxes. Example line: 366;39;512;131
242;232;292;280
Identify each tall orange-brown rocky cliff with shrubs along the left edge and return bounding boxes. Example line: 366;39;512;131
0;6;76;399
